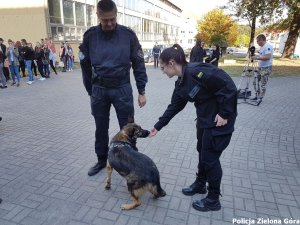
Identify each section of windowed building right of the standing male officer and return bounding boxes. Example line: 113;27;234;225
115;0;182;48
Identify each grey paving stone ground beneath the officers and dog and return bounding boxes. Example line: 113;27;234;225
0;66;300;225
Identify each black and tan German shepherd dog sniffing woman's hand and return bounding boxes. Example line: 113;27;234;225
105;120;166;210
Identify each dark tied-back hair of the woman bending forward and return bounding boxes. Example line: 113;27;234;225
159;44;187;65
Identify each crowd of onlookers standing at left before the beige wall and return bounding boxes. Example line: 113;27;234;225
0;38;74;89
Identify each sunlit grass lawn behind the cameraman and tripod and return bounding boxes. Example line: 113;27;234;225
219;55;300;77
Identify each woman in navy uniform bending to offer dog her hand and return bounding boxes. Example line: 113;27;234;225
149;44;237;211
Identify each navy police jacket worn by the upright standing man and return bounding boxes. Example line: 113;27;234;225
79;24;148;95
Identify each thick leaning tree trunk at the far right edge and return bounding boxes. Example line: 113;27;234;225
282;9;300;58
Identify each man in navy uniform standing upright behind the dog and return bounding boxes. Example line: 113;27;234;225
79;0;148;176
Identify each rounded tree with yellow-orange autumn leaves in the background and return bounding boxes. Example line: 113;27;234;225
196;9;238;47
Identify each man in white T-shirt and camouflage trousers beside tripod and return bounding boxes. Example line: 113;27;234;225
252;34;273;100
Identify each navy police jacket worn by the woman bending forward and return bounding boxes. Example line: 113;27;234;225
154;63;237;135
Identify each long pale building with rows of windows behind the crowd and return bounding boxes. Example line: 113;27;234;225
0;0;182;59
